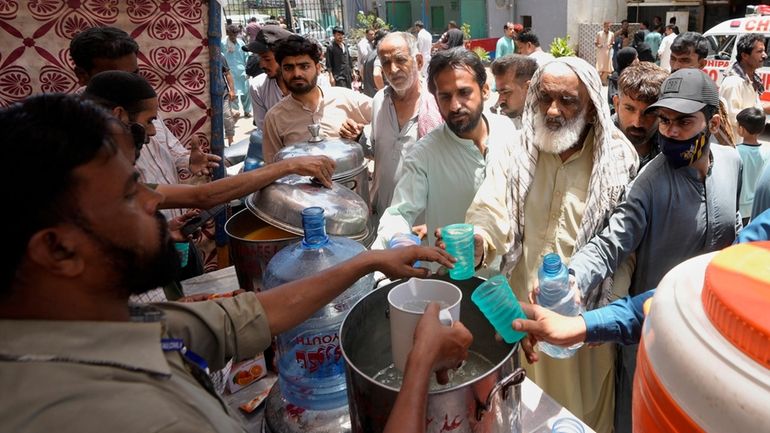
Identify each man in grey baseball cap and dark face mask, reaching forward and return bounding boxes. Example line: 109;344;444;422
570;69;741;431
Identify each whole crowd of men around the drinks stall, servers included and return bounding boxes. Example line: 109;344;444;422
0;14;770;432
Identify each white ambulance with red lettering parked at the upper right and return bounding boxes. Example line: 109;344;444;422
703;5;770;101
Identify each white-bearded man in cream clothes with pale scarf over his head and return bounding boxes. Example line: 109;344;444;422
466;57;639;432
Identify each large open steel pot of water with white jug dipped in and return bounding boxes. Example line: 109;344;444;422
340;278;524;433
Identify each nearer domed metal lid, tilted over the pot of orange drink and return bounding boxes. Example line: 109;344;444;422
246;175;370;241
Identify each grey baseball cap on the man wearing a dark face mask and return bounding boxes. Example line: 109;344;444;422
644;68;719;114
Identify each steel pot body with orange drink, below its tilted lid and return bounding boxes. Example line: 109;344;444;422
225;209;299;291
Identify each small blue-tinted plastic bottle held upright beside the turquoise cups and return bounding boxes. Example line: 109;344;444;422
537;253;583;359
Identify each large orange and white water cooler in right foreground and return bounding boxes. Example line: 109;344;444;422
633;242;770;433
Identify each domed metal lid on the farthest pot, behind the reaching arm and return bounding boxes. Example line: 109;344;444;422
274;138;366;180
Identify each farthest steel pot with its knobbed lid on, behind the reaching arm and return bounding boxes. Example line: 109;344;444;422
274;125;371;206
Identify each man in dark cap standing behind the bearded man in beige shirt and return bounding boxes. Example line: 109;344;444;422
243;25;292;159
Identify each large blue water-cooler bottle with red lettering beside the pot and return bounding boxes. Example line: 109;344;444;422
263;207;374;410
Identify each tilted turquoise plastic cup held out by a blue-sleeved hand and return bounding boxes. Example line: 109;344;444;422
471;275;527;344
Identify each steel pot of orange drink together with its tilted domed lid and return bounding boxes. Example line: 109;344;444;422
225;175;377;290
